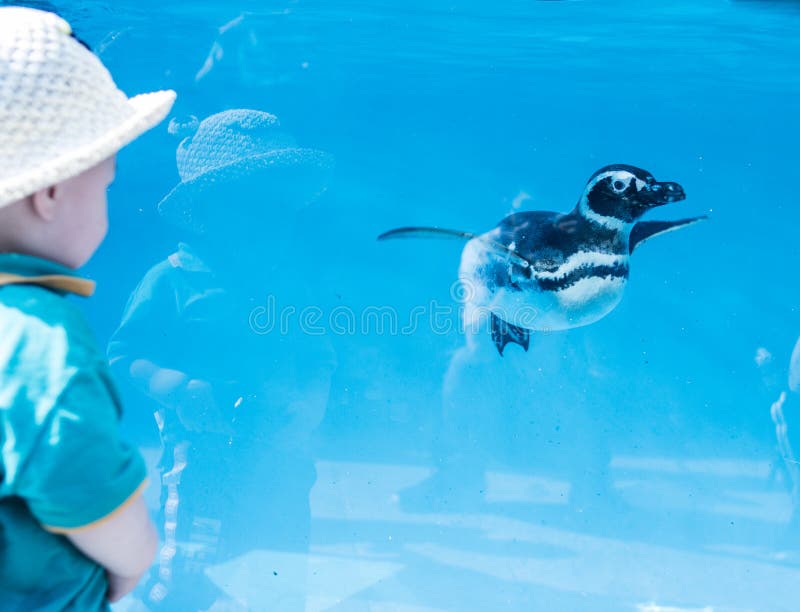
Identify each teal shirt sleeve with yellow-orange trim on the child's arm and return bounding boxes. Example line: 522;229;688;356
16;363;147;531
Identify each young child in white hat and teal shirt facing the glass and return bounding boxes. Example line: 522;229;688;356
0;7;175;612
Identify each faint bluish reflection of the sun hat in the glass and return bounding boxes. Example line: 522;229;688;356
158;109;333;234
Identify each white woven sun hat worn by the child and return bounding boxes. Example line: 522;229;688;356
0;7;175;207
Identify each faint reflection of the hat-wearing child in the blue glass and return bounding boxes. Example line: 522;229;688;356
109;110;335;610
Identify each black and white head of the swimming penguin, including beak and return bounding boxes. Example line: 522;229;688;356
578;164;686;229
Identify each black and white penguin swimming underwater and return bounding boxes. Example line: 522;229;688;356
378;164;706;355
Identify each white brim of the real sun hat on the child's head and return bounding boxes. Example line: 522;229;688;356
0;90;176;207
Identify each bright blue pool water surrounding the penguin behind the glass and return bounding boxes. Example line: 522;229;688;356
36;0;800;612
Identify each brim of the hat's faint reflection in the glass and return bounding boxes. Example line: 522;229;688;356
158;148;334;235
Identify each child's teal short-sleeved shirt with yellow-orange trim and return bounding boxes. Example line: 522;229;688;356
0;254;146;612
